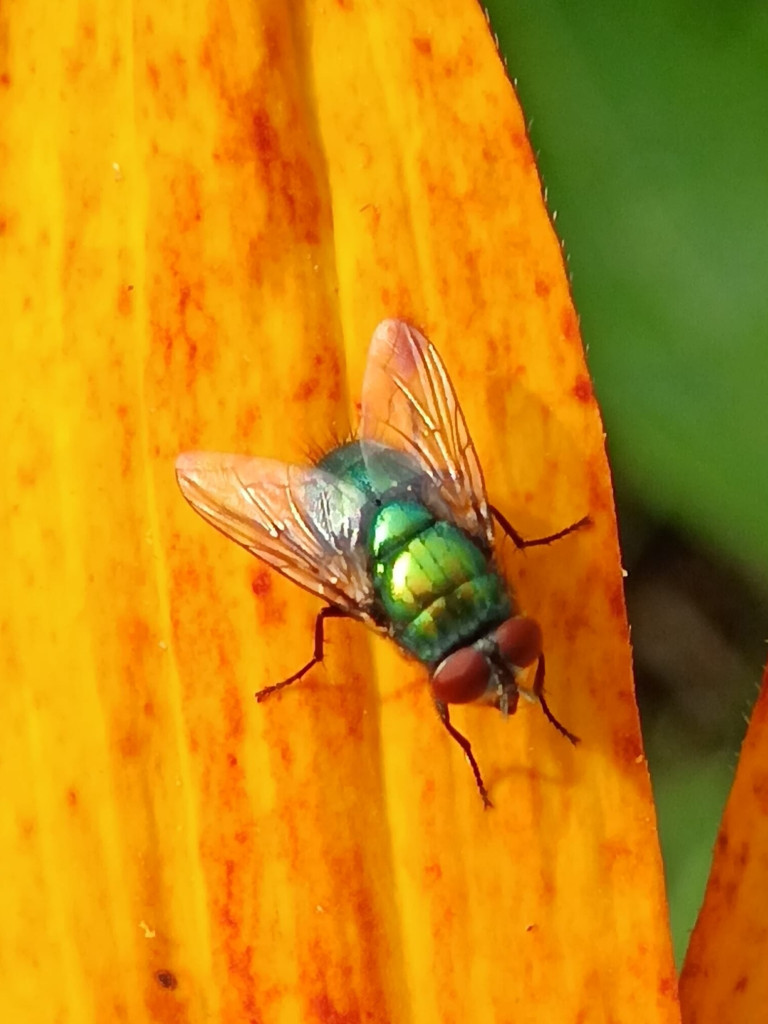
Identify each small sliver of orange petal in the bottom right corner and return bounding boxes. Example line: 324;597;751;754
680;670;768;1024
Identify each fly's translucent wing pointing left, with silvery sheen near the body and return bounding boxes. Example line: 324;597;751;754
176;452;373;620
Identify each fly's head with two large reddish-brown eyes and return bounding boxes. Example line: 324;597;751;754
431;615;542;716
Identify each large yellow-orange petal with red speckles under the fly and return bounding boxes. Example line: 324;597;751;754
0;0;679;1024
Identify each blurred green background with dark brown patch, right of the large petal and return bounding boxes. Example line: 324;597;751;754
487;0;768;961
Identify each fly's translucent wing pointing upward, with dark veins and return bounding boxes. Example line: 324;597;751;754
358;319;494;548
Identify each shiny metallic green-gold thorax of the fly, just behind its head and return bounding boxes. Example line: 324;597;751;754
370;501;511;665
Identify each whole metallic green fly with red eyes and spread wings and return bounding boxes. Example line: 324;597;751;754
176;319;589;807
